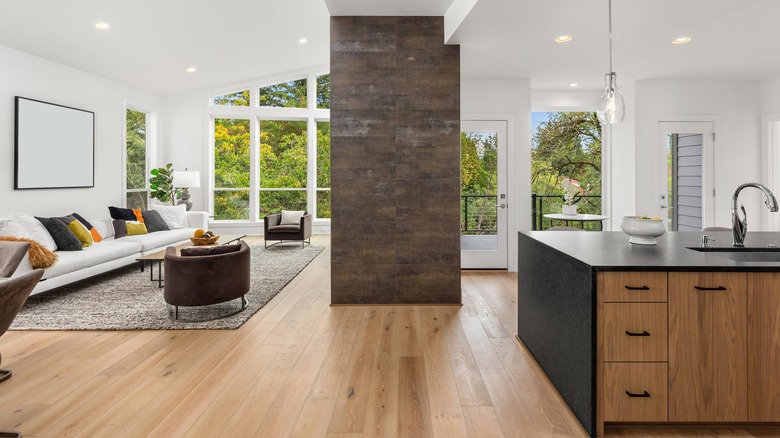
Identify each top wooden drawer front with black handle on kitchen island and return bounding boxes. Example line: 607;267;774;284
597;271;667;303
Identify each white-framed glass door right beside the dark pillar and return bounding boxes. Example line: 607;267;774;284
460;120;509;269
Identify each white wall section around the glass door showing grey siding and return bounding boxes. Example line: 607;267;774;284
632;81;760;230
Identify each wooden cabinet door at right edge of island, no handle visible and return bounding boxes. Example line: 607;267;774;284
748;272;780;422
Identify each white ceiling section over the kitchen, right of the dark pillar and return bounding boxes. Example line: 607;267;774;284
450;0;780;89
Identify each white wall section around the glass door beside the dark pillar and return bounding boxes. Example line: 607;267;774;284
460;78;531;271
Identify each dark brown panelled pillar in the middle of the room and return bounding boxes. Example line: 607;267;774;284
330;17;461;304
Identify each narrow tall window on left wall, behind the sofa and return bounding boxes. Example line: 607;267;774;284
125;109;149;210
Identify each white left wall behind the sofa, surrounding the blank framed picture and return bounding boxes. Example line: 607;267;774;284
0;46;163;217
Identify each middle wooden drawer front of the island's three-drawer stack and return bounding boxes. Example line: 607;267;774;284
602;303;667;362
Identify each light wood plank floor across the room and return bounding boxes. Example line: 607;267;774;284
0;236;777;438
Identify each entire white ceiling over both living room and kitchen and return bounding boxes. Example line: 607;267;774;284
0;0;780;94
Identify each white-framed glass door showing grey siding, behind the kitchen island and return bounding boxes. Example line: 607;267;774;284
658;122;715;231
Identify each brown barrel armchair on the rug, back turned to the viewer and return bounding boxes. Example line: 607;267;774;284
163;240;251;322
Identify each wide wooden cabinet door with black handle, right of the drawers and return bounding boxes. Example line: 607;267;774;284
669;272;747;422
